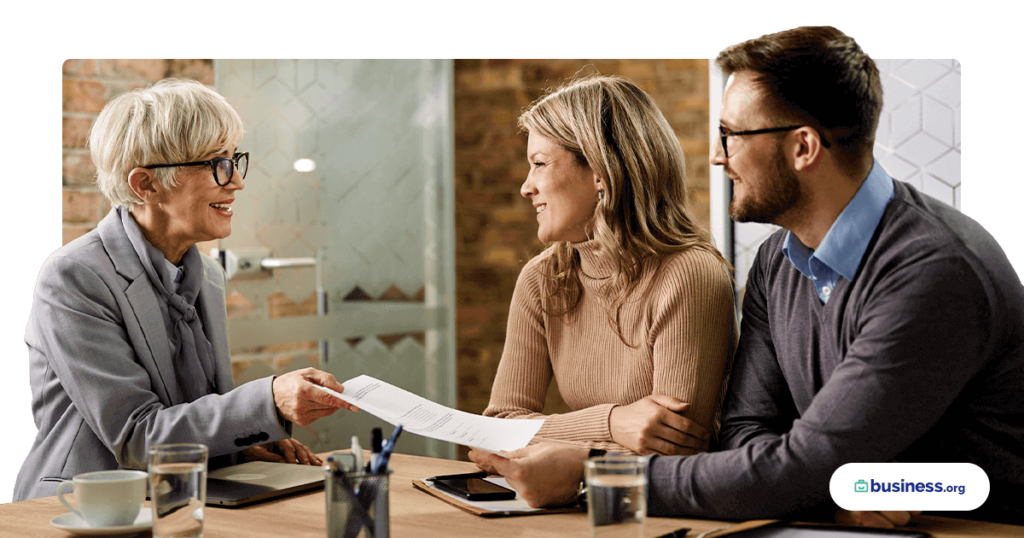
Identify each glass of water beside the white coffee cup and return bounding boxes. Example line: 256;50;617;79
150;445;209;538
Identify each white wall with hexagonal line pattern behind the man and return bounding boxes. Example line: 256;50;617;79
726;58;963;289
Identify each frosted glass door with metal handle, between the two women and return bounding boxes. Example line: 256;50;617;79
216;58;455;456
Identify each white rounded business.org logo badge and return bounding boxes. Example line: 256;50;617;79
828;463;990;510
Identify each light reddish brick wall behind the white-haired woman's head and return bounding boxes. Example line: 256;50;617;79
59;58;213;251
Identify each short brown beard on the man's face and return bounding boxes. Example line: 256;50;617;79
729;144;801;223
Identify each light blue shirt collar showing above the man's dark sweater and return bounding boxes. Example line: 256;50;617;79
782;160;896;302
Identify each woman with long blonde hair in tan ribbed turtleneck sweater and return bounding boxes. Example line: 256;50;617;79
470;76;737;461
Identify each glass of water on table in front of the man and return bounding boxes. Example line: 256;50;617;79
584;456;647;538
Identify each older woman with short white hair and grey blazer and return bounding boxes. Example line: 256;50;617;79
12;80;349;501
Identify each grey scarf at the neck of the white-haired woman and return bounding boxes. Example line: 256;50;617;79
118;208;216;402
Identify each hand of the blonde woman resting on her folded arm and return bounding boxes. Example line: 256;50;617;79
610;395;711;456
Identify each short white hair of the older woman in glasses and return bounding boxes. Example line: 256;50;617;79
89;79;245;210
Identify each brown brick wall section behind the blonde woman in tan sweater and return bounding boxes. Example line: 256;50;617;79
455;58;710;457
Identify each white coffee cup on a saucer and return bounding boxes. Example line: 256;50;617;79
57;470;148;527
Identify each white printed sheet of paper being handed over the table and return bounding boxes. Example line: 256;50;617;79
316;375;544;456
